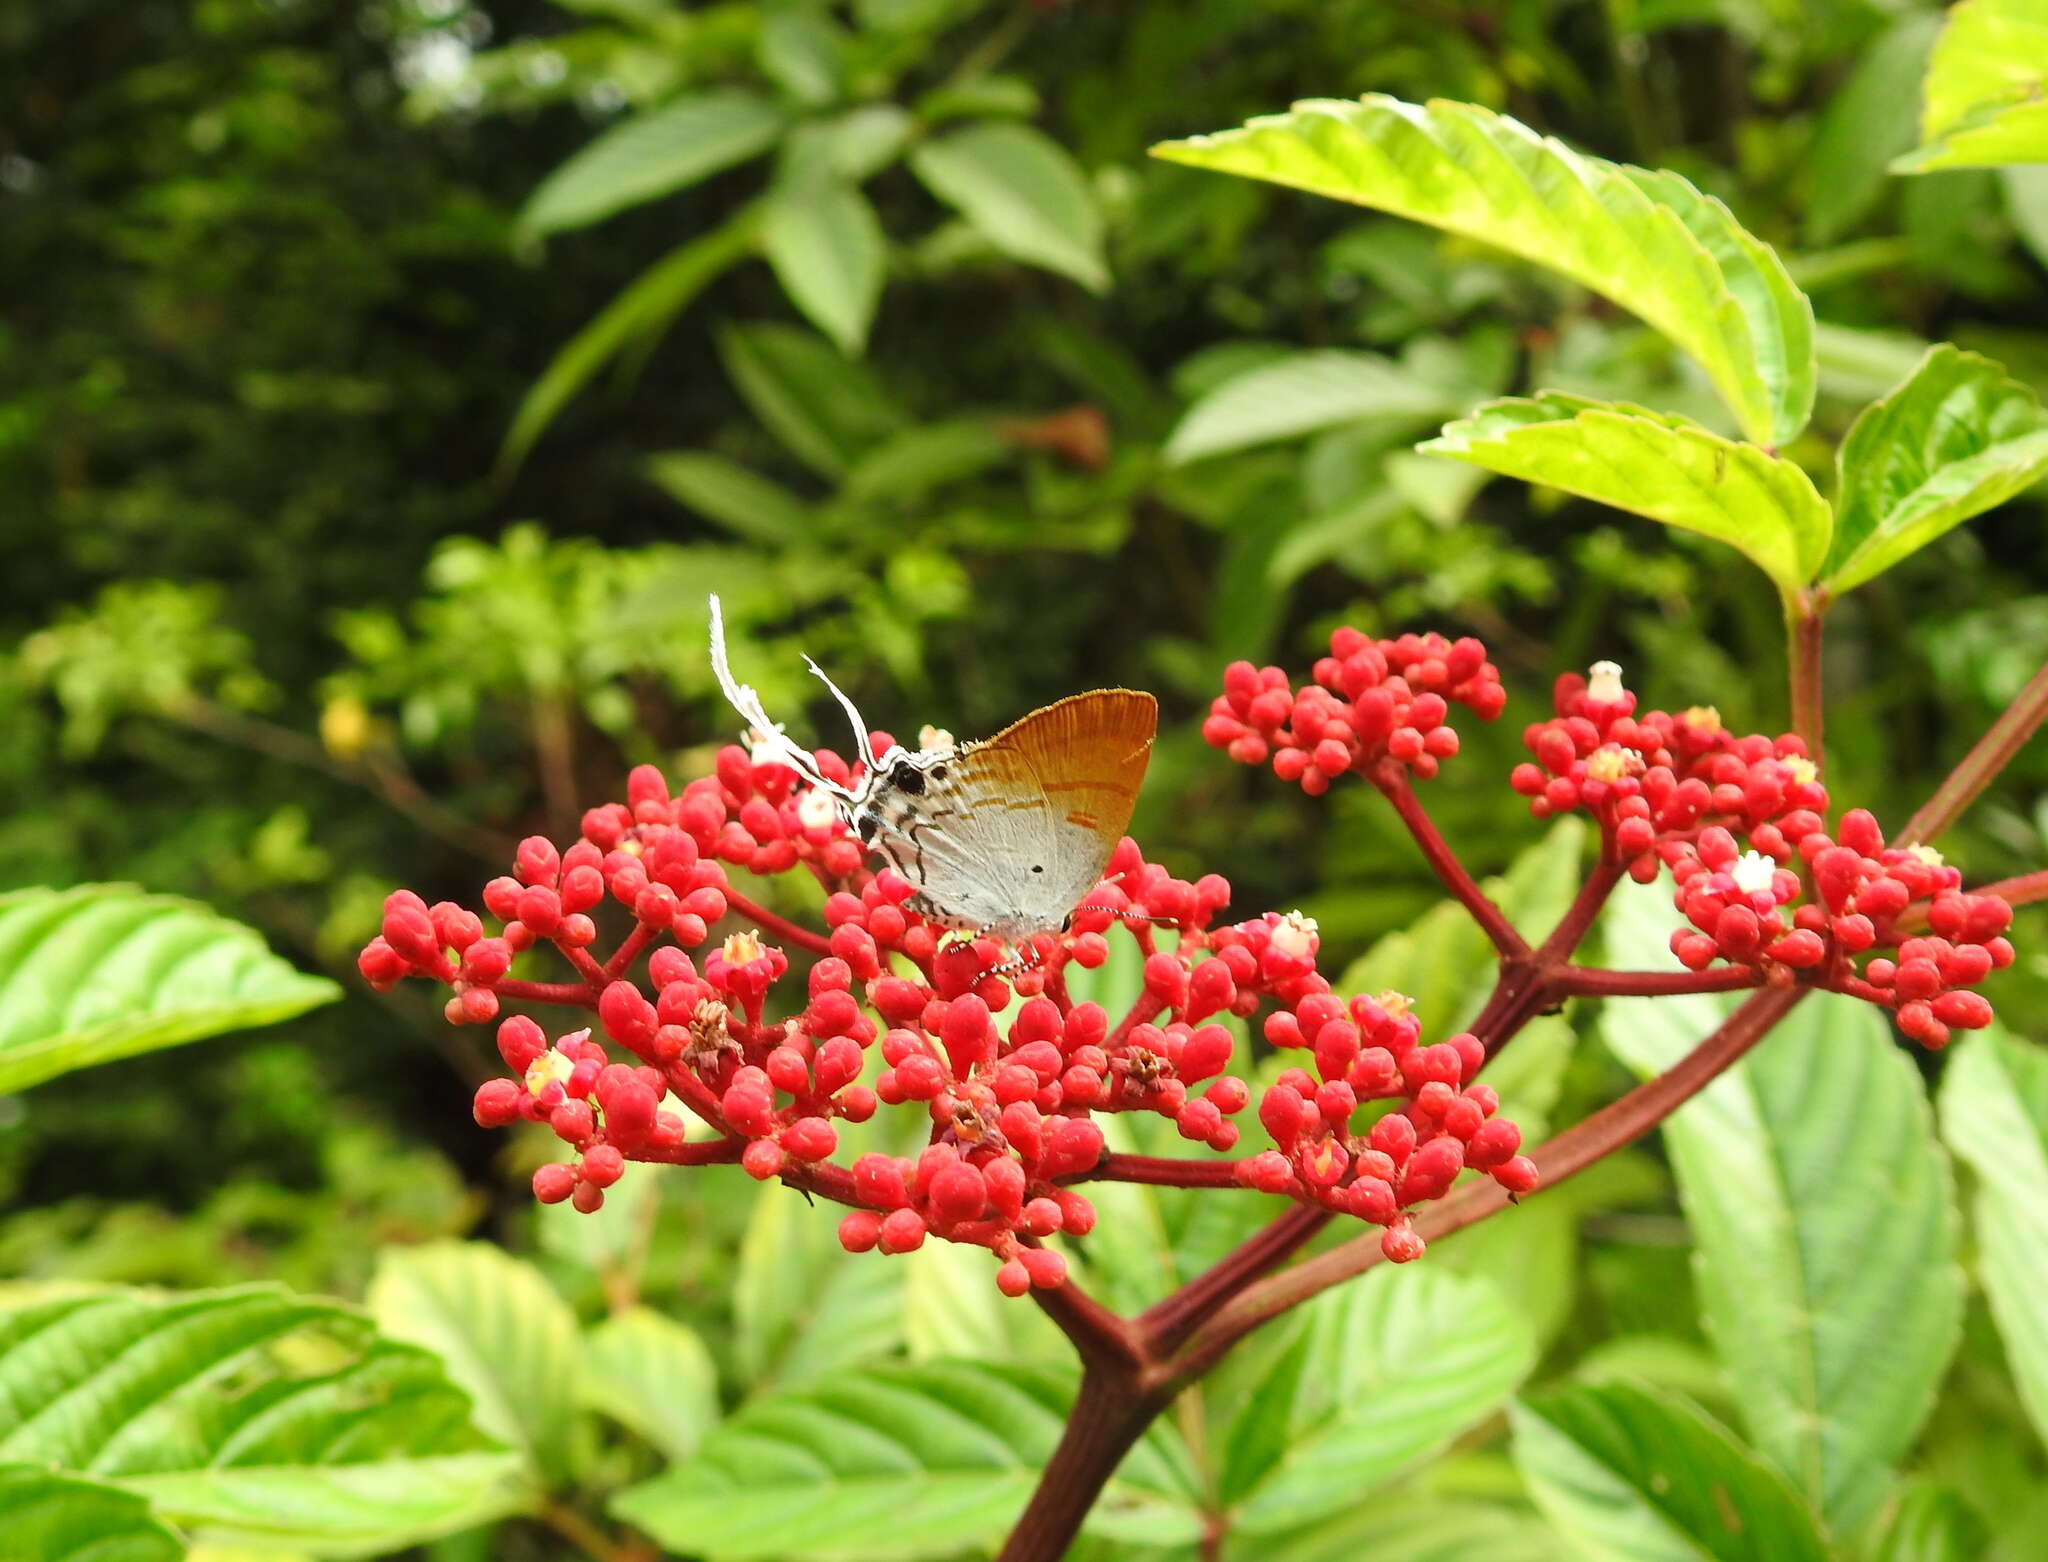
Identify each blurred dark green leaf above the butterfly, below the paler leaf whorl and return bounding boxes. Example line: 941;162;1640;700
719;326;903;477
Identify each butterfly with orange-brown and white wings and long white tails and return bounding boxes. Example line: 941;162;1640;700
711;598;1159;946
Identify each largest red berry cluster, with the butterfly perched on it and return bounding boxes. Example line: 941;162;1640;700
376;747;1515;1292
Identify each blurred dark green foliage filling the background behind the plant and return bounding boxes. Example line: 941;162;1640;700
12;0;2048;1562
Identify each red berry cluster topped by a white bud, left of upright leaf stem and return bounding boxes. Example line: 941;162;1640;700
1509;661;1827;884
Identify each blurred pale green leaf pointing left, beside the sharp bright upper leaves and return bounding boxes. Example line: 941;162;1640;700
1165;348;1456;465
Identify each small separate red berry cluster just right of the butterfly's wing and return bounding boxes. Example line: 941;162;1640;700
1202;628;1507;796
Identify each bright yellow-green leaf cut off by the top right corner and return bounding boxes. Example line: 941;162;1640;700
1892;0;2048;174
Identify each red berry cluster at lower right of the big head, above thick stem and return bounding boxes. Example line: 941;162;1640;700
1237;985;1536;1263
